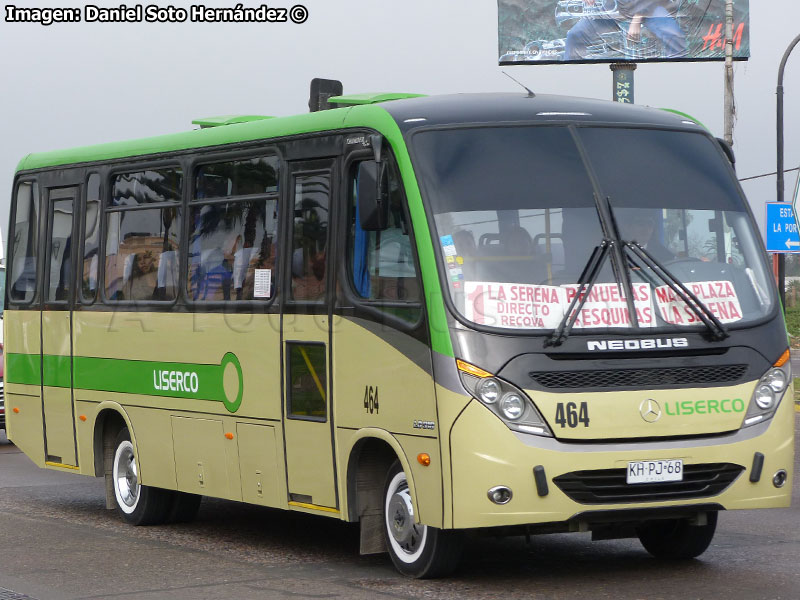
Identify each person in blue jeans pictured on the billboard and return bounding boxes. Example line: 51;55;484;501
564;0;688;60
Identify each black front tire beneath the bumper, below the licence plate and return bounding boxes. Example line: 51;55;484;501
636;512;717;560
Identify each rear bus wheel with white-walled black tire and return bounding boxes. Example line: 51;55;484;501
111;427;170;525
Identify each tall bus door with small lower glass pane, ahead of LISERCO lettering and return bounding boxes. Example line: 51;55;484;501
282;160;338;512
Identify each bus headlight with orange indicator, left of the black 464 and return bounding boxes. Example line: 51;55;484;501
457;360;553;437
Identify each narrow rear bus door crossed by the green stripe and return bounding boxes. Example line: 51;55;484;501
42;187;79;467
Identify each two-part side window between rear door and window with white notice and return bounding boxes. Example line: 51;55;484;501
105;169;183;301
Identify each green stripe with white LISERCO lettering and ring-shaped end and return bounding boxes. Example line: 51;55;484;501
6;352;244;412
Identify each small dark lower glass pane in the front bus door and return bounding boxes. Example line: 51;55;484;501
286;343;328;421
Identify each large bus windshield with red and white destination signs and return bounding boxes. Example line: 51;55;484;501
413;126;775;331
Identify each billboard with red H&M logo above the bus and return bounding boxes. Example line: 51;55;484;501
498;0;750;65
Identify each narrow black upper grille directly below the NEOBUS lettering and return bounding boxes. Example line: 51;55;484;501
529;365;747;389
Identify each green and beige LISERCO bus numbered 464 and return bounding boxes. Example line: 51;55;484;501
5;88;794;577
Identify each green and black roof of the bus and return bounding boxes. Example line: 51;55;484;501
17;93;701;171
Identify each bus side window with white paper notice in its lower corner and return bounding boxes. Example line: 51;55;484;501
187;156;279;302
